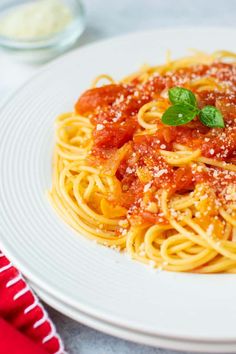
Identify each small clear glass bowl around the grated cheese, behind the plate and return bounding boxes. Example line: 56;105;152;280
0;0;85;63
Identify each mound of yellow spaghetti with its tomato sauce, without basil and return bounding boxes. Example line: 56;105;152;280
49;51;236;273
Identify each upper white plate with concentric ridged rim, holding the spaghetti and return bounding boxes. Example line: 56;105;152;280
0;29;236;342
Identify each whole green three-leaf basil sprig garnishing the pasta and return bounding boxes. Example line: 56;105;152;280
162;86;225;128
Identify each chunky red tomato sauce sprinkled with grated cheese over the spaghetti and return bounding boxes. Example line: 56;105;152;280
75;63;236;223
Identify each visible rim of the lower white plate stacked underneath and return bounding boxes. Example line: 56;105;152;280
30;283;236;353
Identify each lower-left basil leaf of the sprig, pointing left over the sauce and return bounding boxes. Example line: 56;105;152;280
161;104;199;126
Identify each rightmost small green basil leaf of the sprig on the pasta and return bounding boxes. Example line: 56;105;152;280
199;106;225;128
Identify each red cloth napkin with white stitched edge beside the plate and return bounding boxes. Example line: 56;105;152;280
0;251;64;354
